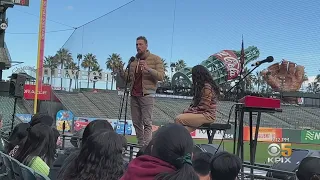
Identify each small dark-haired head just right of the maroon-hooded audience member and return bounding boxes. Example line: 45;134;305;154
192;152;213;180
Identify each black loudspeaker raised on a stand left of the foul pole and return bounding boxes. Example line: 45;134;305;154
9;74;26;98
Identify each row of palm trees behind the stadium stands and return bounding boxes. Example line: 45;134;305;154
44;48;320;93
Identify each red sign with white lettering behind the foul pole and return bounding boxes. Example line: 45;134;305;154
24;84;51;101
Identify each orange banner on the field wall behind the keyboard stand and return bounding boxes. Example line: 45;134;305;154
243;126;282;142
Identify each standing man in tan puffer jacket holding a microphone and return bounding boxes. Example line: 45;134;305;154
120;36;164;146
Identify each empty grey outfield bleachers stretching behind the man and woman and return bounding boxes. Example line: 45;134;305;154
50;91;320;129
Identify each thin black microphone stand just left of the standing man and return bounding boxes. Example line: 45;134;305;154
119;61;131;136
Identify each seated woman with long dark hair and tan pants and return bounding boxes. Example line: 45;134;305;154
175;65;220;132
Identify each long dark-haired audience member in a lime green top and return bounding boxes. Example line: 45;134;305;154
13;123;55;176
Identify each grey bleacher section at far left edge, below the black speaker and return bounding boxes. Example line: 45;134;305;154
0;96;28;132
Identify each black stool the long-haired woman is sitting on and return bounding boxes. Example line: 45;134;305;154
197;123;231;144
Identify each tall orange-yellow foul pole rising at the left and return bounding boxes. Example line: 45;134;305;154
33;0;47;114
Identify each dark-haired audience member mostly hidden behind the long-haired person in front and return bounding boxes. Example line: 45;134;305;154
53;119;114;179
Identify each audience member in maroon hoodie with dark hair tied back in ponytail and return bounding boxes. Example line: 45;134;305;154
120;124;199;180
